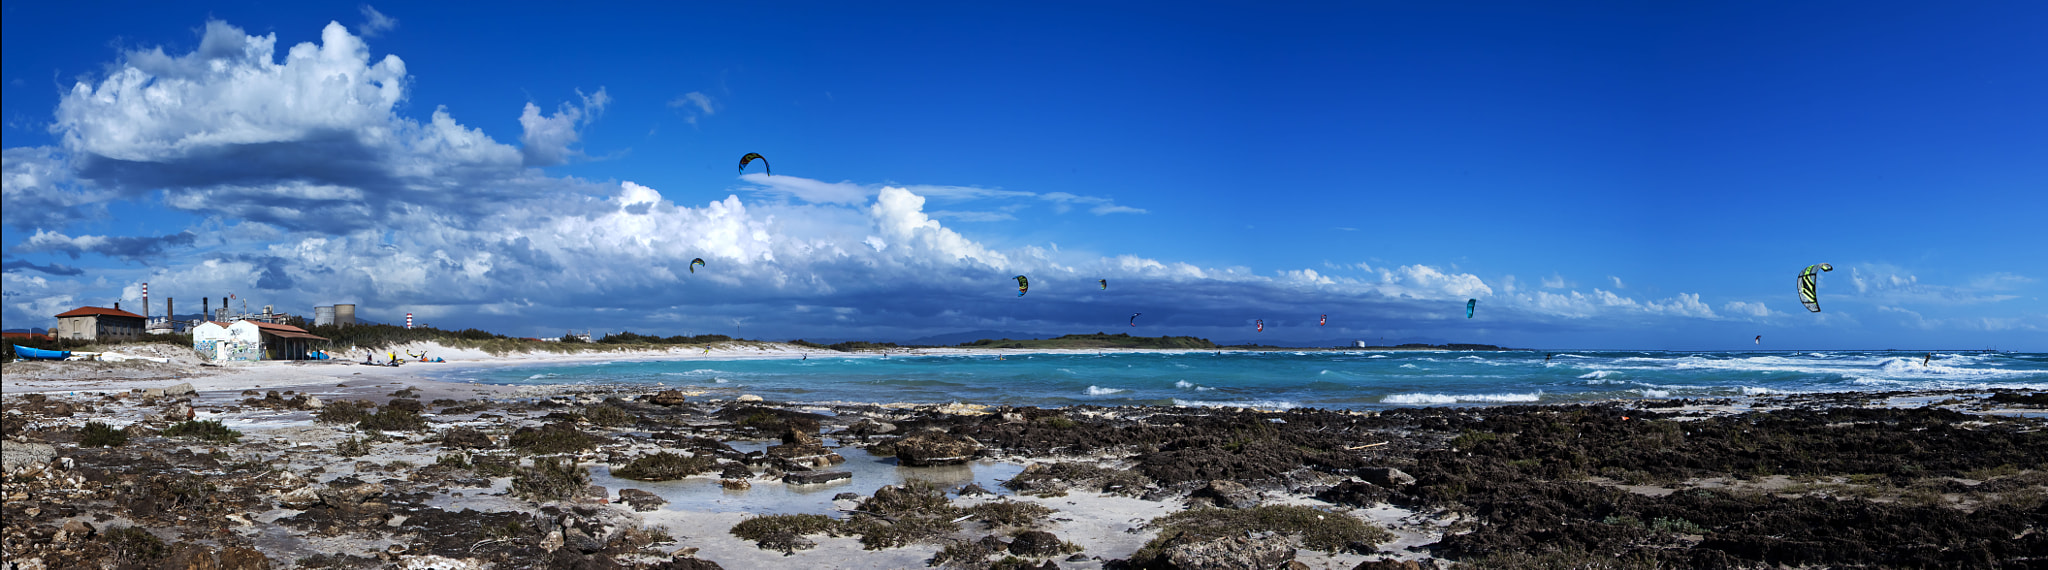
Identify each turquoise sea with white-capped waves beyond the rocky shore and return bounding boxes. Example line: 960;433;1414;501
442;351;2048;408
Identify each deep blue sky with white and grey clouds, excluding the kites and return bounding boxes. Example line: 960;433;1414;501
0;2;2048;351
